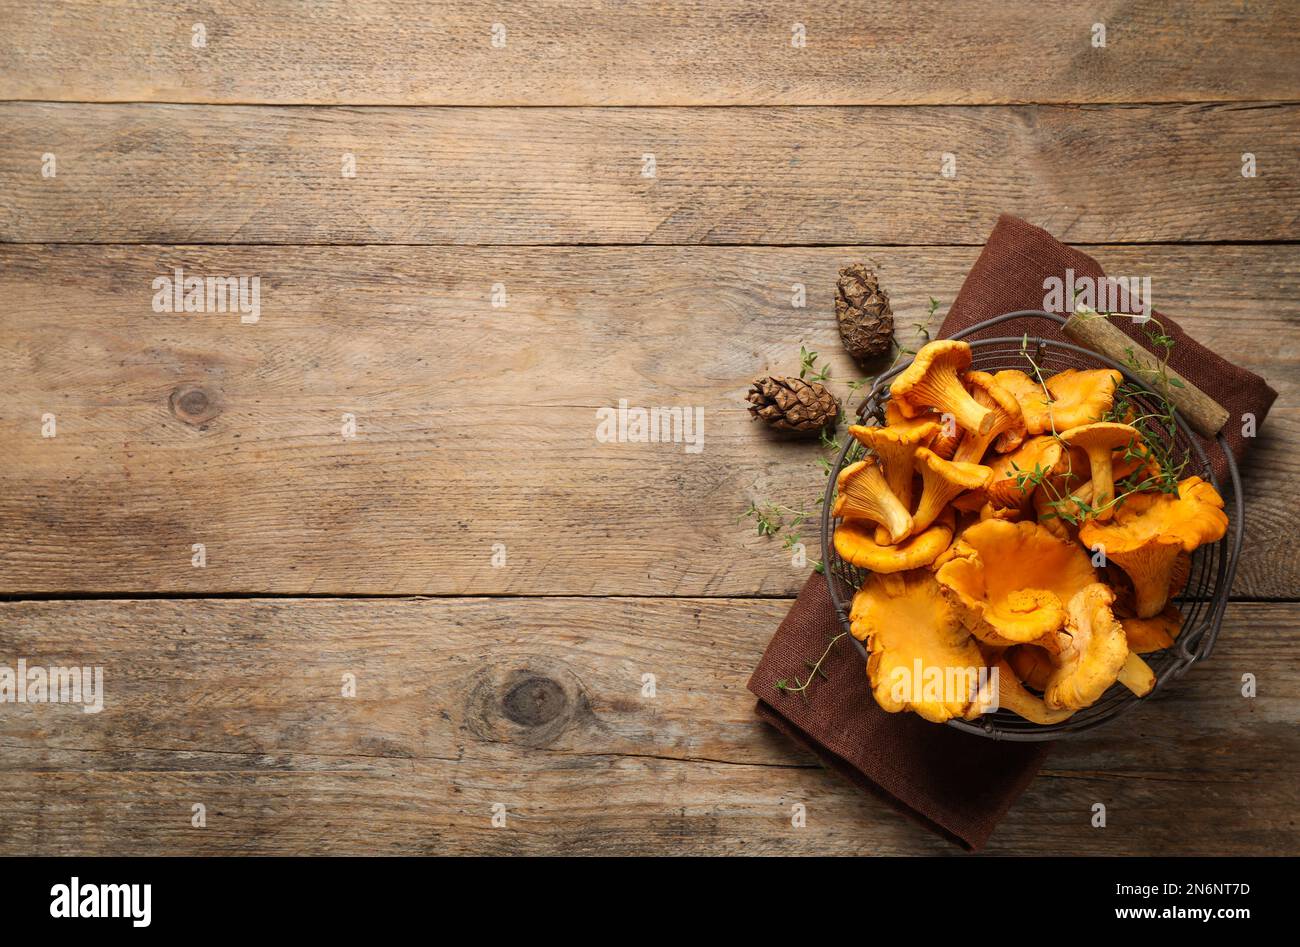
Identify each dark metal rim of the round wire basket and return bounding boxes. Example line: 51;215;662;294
822;310;1245;743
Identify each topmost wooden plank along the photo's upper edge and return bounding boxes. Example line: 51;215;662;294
0;0;1300;105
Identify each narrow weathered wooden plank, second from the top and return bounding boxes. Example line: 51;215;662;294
0;103;1300;245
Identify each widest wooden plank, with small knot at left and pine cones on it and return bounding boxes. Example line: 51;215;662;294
0;246;1300;597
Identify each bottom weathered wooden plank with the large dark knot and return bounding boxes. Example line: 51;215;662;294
0;598;1300;855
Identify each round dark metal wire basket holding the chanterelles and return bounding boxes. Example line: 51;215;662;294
822;310;1245;741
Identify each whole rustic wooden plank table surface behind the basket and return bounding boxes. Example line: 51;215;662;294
0;0;1300;855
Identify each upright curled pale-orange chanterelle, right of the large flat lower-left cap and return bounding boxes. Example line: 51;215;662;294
1043;583;1128;710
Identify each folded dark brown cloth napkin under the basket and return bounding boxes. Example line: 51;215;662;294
749;216;1277;851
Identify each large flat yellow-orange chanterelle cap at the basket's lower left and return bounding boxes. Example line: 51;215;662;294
849;568;984;723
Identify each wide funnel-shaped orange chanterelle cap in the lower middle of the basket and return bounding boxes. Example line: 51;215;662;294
937;519;1097;645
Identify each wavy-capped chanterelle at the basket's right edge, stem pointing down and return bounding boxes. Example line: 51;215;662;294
1079;477;1227;618
